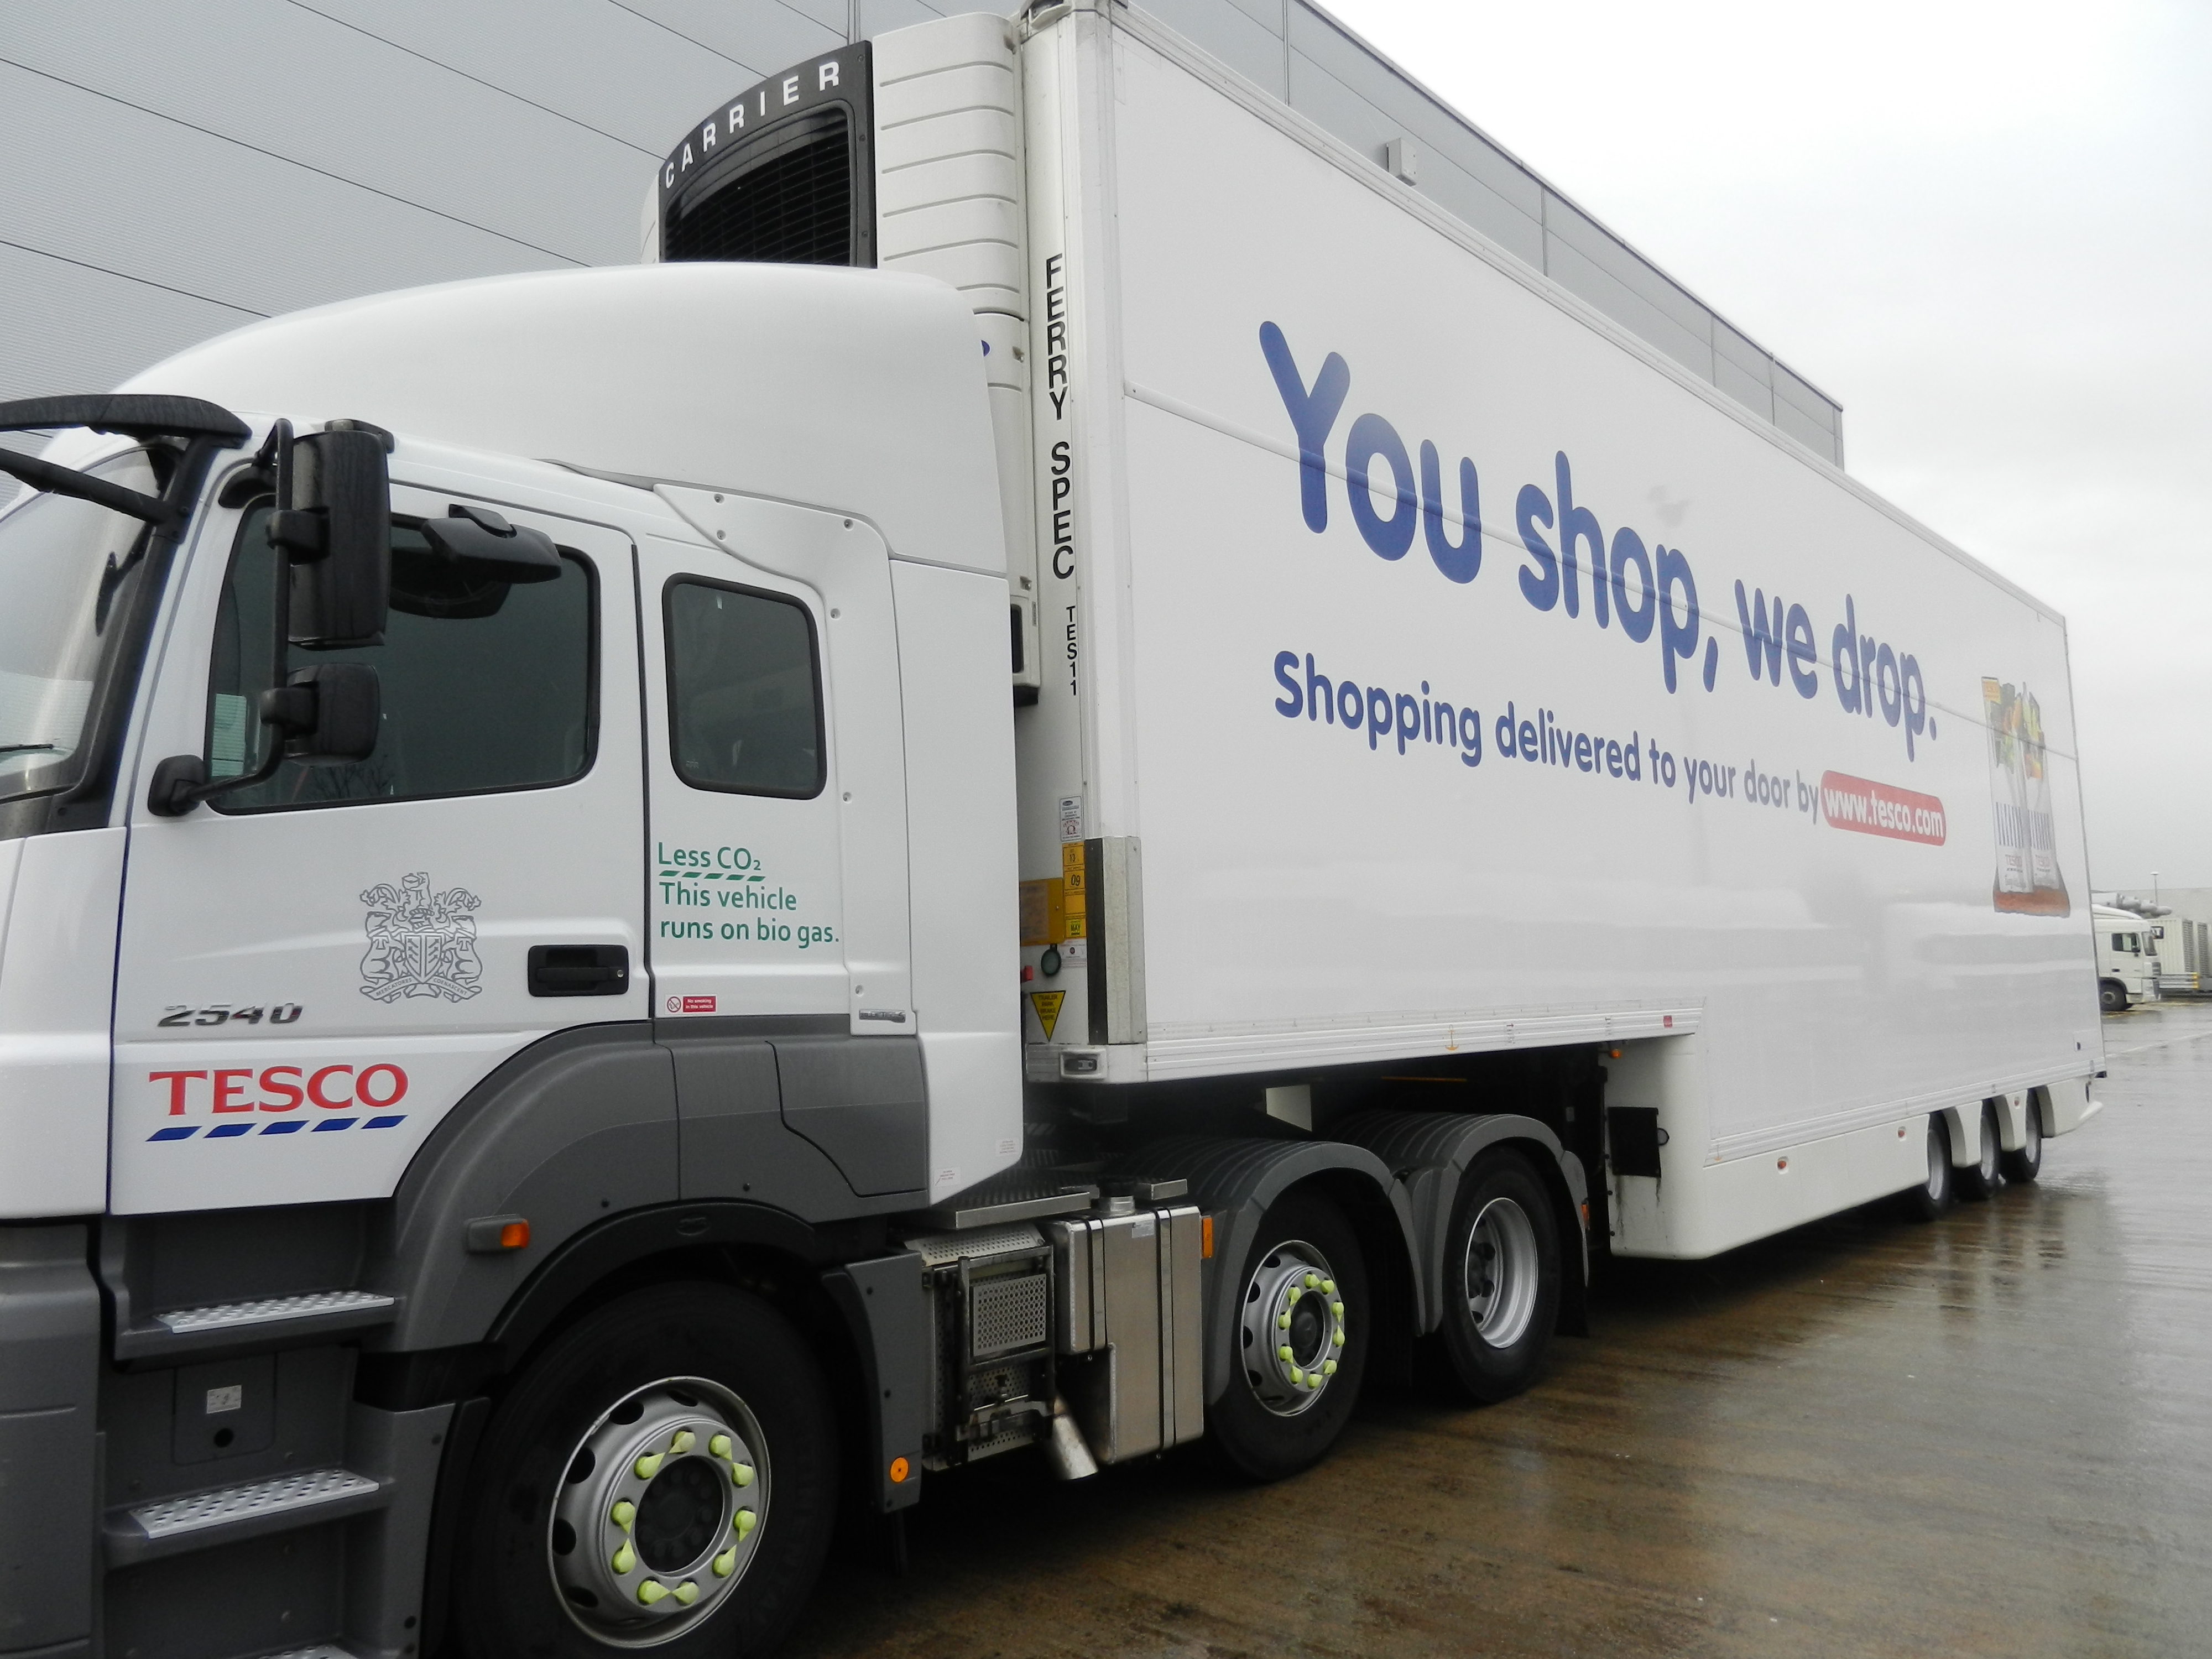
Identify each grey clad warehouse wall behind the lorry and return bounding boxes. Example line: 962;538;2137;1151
0;0;1843;500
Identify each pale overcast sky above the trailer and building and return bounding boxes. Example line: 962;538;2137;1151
1323;0;2212;891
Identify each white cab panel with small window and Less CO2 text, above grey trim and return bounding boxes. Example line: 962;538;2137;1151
639;487;914;1035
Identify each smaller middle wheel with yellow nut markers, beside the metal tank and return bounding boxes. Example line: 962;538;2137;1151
1210;1192;1369;1480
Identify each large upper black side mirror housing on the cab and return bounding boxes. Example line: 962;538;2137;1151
270;427;392;648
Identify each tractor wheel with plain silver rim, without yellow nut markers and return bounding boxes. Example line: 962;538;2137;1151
1442;1150;1559;1405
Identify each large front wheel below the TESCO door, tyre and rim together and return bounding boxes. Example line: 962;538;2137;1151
453;1283;836;1659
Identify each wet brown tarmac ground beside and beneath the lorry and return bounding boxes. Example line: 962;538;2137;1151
787;1004;2212;1659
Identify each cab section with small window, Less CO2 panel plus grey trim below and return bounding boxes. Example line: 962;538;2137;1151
639;487;929;1206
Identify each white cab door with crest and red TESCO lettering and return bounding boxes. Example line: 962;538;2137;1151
111;480;646;1212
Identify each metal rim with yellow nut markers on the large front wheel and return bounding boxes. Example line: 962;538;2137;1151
546;1376;768;1648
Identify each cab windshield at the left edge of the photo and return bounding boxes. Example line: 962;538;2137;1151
0;449;161;801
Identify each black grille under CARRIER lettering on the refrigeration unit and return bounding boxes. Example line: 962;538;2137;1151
661;104;858;265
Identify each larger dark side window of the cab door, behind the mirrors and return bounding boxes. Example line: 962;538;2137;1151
208;507;597;812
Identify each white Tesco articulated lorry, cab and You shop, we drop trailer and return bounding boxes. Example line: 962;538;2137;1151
0;4;2099;1659
